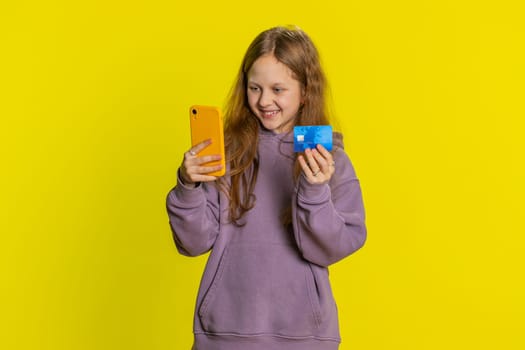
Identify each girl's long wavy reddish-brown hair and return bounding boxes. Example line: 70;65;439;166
219;27;329;225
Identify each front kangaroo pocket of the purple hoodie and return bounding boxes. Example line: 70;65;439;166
199;244;322;337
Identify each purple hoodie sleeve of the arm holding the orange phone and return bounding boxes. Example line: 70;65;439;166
166;171;219;256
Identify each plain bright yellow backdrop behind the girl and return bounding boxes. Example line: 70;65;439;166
0;0;525;350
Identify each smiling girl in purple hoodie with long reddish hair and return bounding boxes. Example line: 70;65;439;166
167;27;366;350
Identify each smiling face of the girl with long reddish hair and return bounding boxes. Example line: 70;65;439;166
247;55;303;134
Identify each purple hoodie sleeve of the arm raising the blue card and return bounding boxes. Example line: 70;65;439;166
292;148;366;267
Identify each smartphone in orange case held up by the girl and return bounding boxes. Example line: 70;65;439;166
190;105;226;176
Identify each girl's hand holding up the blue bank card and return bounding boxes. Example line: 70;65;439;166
298;145;335;184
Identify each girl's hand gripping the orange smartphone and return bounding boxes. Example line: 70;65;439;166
179;139;222;186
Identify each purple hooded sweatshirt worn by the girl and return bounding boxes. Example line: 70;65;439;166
167;130;366;350
